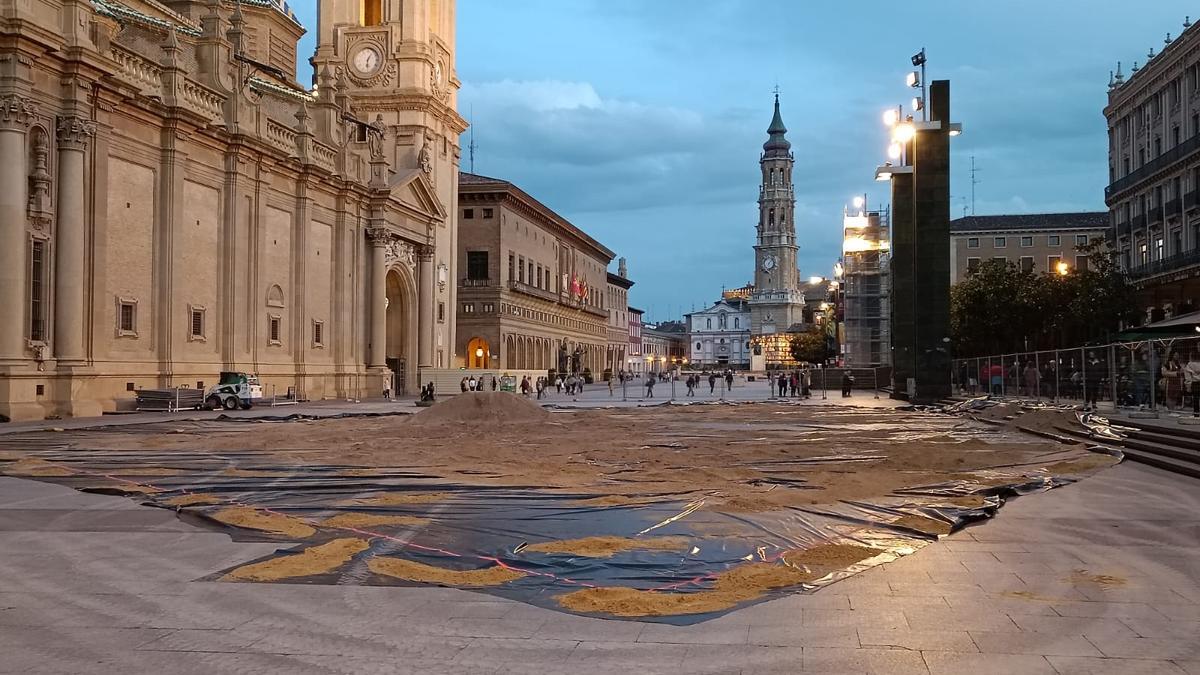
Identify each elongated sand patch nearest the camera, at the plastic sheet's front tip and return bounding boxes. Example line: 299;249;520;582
557;562;820;617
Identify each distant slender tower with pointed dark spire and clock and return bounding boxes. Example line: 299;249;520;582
750;94;804;335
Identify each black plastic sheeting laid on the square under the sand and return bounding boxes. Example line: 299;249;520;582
0;404;1120;625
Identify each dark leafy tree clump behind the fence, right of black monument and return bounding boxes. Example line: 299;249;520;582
950;239;1136;357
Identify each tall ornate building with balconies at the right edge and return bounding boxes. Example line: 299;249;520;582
1104;18;1200;321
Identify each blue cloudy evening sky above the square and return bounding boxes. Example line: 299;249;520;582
292;0;1200;319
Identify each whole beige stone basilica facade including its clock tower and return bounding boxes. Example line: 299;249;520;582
0;0;466;419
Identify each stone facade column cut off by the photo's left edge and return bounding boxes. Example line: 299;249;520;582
0;94;37;362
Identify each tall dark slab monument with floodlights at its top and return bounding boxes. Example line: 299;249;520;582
892;79;959;404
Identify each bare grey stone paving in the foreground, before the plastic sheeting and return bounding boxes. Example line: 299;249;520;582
0;449;1200;675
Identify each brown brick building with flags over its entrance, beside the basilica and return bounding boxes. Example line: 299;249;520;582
456;173;614;378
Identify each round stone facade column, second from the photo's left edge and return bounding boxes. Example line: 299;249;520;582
54;115;96;365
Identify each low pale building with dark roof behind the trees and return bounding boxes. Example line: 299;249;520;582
950;211;1109;283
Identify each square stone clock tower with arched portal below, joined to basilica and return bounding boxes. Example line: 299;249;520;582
312;0;467;369
